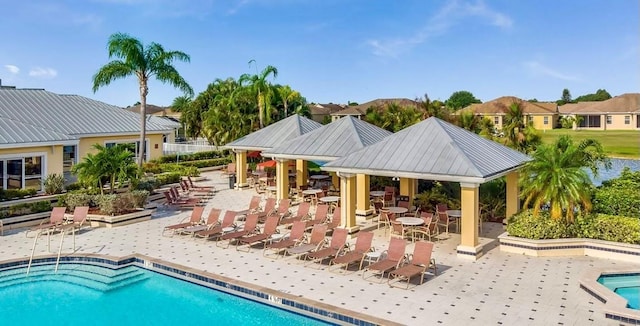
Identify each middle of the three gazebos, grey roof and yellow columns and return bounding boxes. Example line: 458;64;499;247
262;117;392;232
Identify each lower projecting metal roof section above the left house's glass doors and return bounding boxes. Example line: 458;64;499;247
0;117;78;147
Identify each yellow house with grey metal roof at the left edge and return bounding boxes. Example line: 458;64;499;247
0;87;177;190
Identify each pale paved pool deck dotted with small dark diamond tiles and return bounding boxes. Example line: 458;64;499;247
0;172;638;325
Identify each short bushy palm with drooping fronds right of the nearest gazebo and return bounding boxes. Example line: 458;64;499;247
520;136;610;222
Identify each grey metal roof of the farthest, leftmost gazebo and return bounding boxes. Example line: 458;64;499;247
224;114;322;151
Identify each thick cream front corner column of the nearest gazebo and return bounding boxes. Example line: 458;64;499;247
456;183;482;260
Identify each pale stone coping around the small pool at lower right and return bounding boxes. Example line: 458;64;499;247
578;269;640;324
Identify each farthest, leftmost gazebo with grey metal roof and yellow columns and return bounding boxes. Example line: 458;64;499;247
224;114;322;189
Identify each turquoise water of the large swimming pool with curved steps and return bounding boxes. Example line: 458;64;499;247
0;264;327;325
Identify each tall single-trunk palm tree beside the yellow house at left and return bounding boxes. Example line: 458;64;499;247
93;33;193;167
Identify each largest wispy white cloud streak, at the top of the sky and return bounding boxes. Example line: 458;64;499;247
367;0;513;57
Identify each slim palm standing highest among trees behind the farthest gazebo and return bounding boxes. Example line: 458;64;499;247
238;60;278;128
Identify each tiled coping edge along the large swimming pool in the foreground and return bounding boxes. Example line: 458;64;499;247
0;254;402;326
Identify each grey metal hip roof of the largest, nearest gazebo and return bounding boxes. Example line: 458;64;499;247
322;117;530;183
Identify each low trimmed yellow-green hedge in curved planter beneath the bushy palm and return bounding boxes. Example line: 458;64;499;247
507;210;640;244
